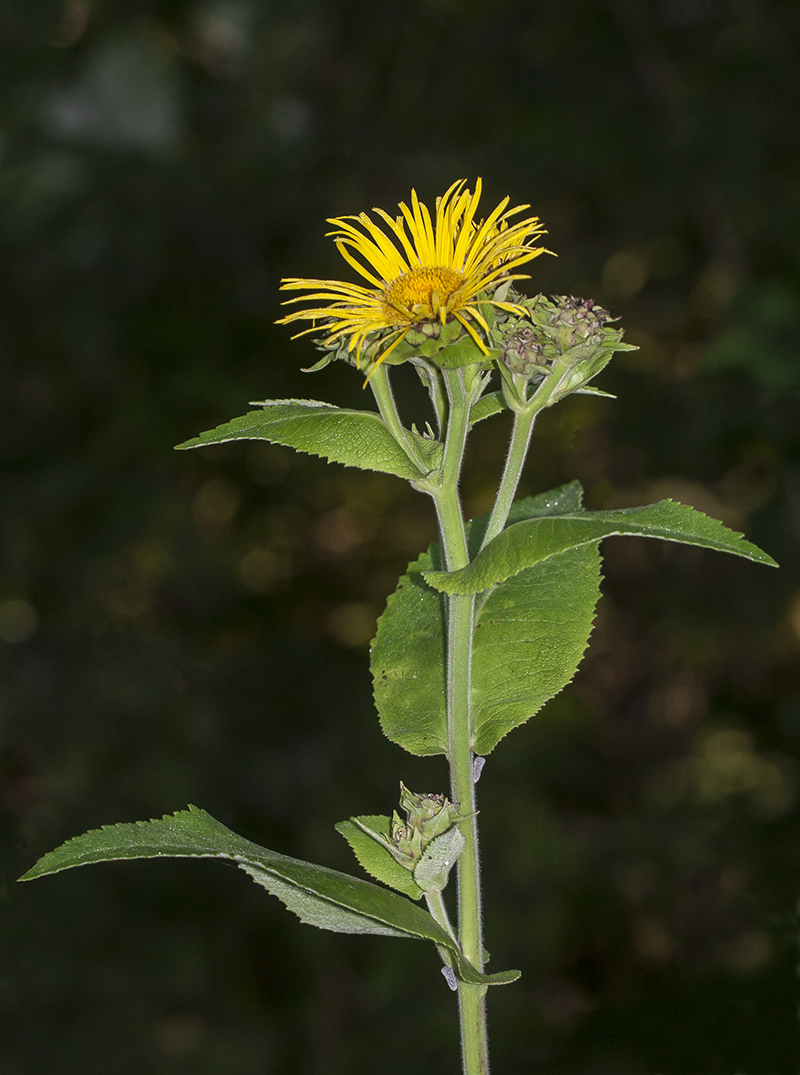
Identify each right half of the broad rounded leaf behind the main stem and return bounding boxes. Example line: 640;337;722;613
472;544;600;755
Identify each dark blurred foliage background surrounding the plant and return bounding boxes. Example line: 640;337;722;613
0;0;800;1075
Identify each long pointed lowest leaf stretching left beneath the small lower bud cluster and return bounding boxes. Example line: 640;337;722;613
20;806;519;985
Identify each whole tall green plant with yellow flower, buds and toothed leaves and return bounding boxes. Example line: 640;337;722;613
23;181;774;1075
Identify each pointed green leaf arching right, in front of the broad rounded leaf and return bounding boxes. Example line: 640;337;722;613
424;500;777;593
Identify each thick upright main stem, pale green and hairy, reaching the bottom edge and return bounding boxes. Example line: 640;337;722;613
433;370;489;1075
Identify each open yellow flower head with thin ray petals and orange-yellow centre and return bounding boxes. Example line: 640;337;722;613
278;180;549;370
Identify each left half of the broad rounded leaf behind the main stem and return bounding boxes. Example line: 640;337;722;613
370;545;447;756
